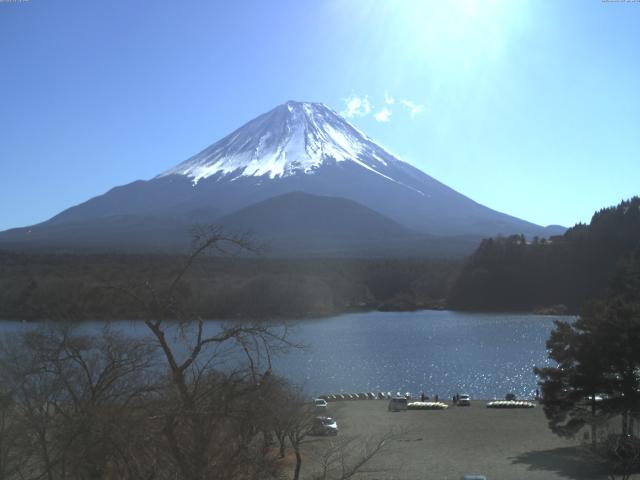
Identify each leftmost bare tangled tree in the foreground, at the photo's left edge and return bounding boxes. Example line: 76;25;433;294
0;325;159;479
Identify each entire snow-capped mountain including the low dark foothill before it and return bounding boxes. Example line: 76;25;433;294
0;101;564;255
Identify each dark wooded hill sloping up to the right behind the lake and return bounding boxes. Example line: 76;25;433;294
449;197;640;313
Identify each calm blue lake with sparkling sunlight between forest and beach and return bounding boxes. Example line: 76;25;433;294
0;310;574;399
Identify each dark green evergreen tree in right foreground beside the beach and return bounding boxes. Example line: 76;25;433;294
535;249;640;442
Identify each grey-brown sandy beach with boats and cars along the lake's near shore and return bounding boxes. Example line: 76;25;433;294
302;400;606;480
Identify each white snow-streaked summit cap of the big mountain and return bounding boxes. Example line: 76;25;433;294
159;101;400;184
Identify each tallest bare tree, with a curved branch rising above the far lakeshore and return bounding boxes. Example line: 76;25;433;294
110;229;292;480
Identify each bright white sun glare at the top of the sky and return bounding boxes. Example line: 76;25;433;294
341;0;528;77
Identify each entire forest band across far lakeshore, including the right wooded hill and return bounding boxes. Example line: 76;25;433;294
5;197;640;320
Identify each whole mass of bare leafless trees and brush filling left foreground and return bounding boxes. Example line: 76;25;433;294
0;226;404;480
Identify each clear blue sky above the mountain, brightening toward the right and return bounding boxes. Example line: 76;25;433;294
0;0;640;229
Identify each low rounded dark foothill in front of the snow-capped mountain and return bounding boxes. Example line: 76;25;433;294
216;192;480;258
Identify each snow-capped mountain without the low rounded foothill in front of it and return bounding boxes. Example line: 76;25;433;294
0;101;558;253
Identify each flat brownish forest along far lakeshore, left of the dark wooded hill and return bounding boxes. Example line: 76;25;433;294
0;252;461;320
